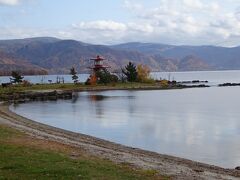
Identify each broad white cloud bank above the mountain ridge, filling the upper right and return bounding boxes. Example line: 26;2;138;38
0;0;240;46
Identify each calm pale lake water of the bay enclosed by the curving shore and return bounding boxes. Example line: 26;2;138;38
11;71;240;168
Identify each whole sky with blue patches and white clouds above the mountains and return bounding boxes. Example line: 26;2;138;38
0;0;240;47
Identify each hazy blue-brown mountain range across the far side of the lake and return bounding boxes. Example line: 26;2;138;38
0;37;240;75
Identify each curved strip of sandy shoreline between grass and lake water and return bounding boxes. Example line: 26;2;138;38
0;104;240;179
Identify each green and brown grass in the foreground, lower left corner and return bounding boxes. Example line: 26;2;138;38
0;125;168;179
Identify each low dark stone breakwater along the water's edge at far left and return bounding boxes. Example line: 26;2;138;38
0;90;73;102
